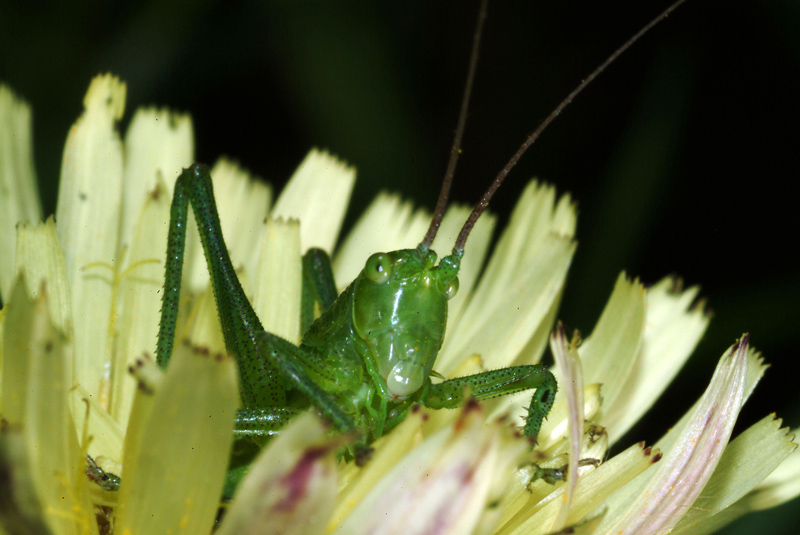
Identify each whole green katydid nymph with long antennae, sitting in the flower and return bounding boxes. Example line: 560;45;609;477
147;0;682;498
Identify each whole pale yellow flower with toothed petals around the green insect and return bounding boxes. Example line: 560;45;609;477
0;76;800;535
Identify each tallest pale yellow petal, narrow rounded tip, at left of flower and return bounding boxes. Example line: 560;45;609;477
56;75;125;406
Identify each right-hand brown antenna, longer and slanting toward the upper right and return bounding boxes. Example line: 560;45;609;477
453;0;686;257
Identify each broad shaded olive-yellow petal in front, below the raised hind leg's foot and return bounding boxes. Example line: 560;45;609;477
116;344;239;533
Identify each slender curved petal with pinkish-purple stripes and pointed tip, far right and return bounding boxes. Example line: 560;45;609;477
607;335;748;535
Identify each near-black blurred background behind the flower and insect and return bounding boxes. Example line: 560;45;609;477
0;0;800;535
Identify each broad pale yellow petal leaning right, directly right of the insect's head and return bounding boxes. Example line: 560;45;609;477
436;182;575;376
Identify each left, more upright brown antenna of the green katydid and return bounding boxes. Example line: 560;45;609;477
417;0;489;253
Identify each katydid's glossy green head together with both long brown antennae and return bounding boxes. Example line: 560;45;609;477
353;0;685;399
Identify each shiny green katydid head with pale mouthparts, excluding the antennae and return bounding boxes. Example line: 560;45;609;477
353;249;461;399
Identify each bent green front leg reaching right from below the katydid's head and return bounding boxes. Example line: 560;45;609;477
421;364;558;440
